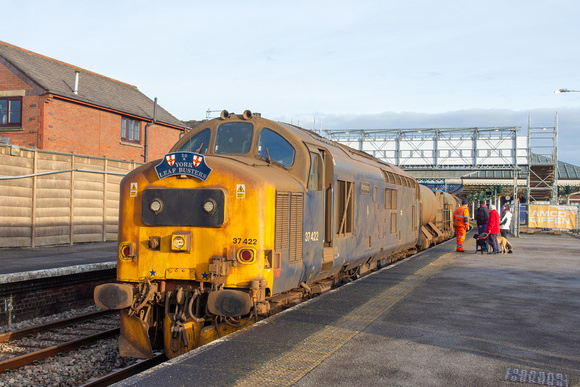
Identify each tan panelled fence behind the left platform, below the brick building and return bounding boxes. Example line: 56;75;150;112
0;144;140;247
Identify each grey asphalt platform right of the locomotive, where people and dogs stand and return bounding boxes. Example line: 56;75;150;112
117;231;580;386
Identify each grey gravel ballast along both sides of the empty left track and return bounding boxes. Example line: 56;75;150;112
0;306;135;387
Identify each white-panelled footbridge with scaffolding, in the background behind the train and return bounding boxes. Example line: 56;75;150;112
322;116;580;204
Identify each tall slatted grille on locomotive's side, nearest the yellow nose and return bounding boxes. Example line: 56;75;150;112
274;192;304;261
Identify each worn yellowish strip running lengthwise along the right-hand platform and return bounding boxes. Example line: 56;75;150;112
235;252;464;387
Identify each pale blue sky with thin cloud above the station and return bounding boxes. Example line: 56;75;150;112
0;0;580;165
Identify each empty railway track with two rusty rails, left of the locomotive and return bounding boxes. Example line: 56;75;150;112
0;310;119;372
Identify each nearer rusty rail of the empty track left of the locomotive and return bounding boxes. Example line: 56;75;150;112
0;328;121;372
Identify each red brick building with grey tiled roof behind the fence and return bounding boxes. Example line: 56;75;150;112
0;41;187;162
